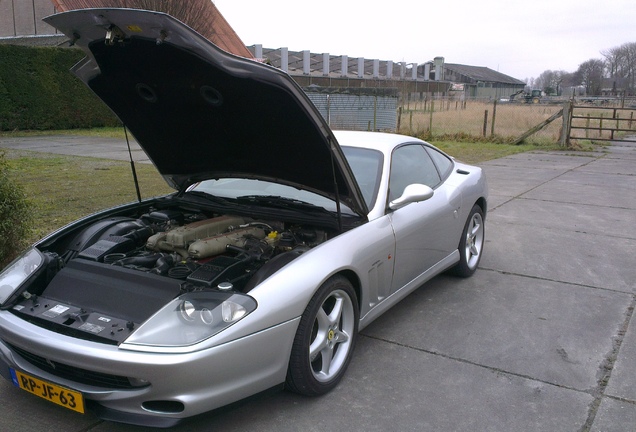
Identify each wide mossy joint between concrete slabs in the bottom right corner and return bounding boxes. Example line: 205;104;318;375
581;295;636;432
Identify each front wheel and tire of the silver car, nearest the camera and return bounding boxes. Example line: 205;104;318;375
286;276;359;396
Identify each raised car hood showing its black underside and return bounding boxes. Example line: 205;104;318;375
44;9;367;216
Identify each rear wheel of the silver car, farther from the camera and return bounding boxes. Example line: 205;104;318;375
452;204;486;278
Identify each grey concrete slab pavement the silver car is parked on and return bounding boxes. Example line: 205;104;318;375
0;137;636;432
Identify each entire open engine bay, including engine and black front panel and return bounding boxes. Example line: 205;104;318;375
11;208;333;344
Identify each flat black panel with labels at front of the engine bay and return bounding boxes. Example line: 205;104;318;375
13;258;183;343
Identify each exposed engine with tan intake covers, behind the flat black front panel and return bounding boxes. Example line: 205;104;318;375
65;210;328;292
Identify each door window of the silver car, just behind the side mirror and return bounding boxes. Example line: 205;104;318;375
389;144;441;200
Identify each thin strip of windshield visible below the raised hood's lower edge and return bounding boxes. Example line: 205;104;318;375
187;178;354;214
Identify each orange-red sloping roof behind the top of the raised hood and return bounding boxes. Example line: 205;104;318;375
51;0;253;58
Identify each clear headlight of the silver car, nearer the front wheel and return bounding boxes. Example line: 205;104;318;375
126;291;256;347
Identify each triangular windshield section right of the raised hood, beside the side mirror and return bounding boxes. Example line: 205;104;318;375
342;147;384;209
